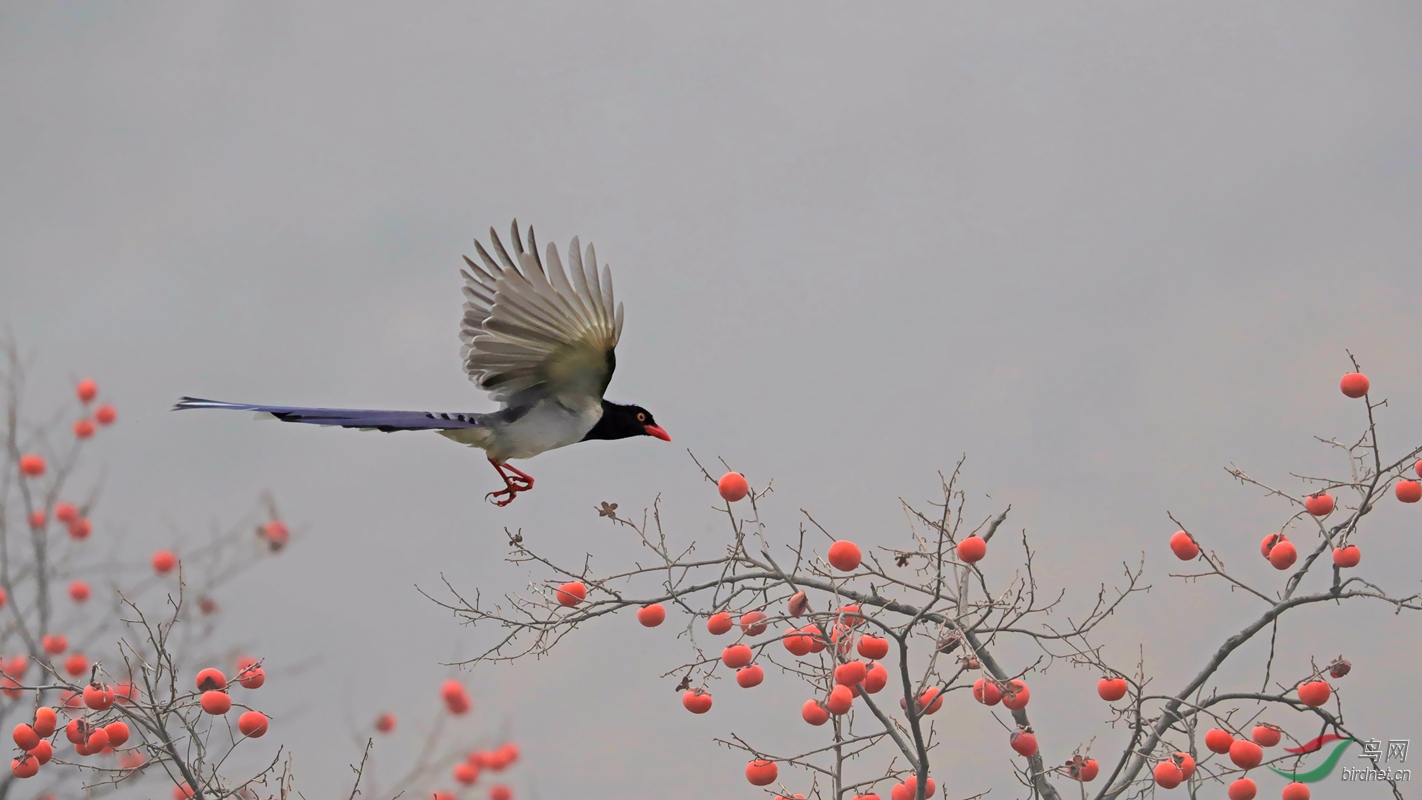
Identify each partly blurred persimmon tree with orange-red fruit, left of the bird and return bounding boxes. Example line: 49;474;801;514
0;342;519;800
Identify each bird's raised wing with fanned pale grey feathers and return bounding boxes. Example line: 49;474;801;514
459;220;623;405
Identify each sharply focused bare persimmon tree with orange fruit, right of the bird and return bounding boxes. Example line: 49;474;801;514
431;365;1422;800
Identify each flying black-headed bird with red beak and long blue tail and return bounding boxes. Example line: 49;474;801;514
173;220;671;506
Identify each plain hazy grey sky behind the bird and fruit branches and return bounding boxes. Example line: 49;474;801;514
0;3;1422;799
